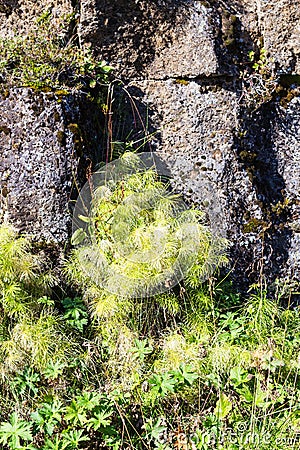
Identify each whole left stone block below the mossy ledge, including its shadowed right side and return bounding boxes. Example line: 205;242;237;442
0;88;103;244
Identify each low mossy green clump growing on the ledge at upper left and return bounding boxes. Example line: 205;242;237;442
0;12;112;95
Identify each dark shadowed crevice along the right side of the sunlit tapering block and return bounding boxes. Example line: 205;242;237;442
234;101;292;283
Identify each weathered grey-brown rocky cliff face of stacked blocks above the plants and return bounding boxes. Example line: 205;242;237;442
0;0;300;283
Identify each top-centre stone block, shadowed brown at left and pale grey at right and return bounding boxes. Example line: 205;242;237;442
79;0;219;79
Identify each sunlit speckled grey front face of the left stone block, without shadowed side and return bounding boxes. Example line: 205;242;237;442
0;89;76;242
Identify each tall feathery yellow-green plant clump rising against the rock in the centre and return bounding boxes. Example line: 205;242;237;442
71;152;227;303
